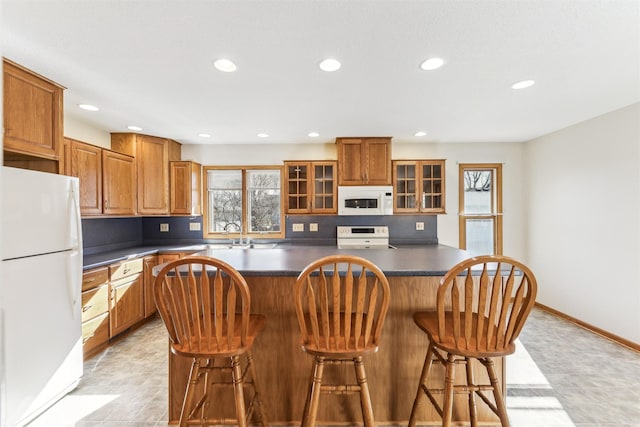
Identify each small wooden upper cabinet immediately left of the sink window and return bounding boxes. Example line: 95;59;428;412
170;161;202;215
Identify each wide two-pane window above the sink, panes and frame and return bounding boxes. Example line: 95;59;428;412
204;166;284;238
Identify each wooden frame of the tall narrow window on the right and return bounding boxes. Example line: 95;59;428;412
458;163;503;255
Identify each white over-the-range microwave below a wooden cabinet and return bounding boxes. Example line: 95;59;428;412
338;185;393;215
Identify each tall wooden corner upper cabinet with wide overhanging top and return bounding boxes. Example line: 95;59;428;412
111;133;181;215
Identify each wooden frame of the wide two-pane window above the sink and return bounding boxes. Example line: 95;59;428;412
202;165;286;239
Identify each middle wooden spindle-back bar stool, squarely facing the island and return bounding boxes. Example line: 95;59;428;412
295;255;389;427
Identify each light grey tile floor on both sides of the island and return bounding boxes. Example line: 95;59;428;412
29;309;640;427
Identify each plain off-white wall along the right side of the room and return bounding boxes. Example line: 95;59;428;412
522;104;640;343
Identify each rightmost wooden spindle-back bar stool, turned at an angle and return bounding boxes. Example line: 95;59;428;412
409;255;537;427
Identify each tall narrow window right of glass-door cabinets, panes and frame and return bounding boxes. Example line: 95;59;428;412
459;164;502;255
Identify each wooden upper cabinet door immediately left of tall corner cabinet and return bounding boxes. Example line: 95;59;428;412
102;150;136;215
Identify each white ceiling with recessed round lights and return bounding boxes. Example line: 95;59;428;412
1;0;640;144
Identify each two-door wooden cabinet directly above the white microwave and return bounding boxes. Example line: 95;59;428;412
336;137;392;185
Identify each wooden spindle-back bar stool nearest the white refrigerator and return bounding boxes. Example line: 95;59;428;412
154;257;267;427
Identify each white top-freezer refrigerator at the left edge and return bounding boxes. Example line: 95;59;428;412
0;167;82;427
